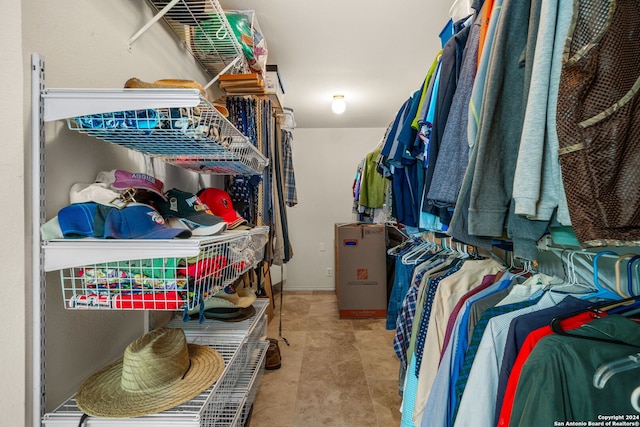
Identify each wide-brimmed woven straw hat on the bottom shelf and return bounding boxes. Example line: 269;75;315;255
76;328;224;418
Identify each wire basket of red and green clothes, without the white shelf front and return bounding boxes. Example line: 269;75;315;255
60;234;248;311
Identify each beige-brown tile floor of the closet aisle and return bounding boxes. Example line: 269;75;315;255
249;290;401;427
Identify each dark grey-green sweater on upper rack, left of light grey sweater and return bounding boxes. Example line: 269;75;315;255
468;0;548;259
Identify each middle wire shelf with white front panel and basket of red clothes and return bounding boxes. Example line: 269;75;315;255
44;227;269;312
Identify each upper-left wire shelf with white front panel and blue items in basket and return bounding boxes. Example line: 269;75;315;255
43;89;268;175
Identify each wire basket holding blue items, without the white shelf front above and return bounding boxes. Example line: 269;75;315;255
67;89;268;175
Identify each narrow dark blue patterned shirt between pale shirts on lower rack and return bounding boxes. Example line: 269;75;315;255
452;294;542;420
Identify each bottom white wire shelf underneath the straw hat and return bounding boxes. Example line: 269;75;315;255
42;336;268;427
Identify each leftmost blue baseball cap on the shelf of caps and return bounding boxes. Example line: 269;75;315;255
58;202;114;239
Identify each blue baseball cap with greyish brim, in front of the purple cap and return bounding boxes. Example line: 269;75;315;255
104;203;191;239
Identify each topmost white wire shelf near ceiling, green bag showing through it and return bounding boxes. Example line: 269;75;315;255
142;0;250;76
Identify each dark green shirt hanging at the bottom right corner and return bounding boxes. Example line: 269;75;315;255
509;315;640;427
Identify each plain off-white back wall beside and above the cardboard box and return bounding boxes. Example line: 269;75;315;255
284;127;384;290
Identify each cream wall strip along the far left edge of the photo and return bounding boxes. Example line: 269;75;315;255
0;1;29;426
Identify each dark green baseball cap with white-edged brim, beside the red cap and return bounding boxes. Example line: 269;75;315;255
156;188;227;236
